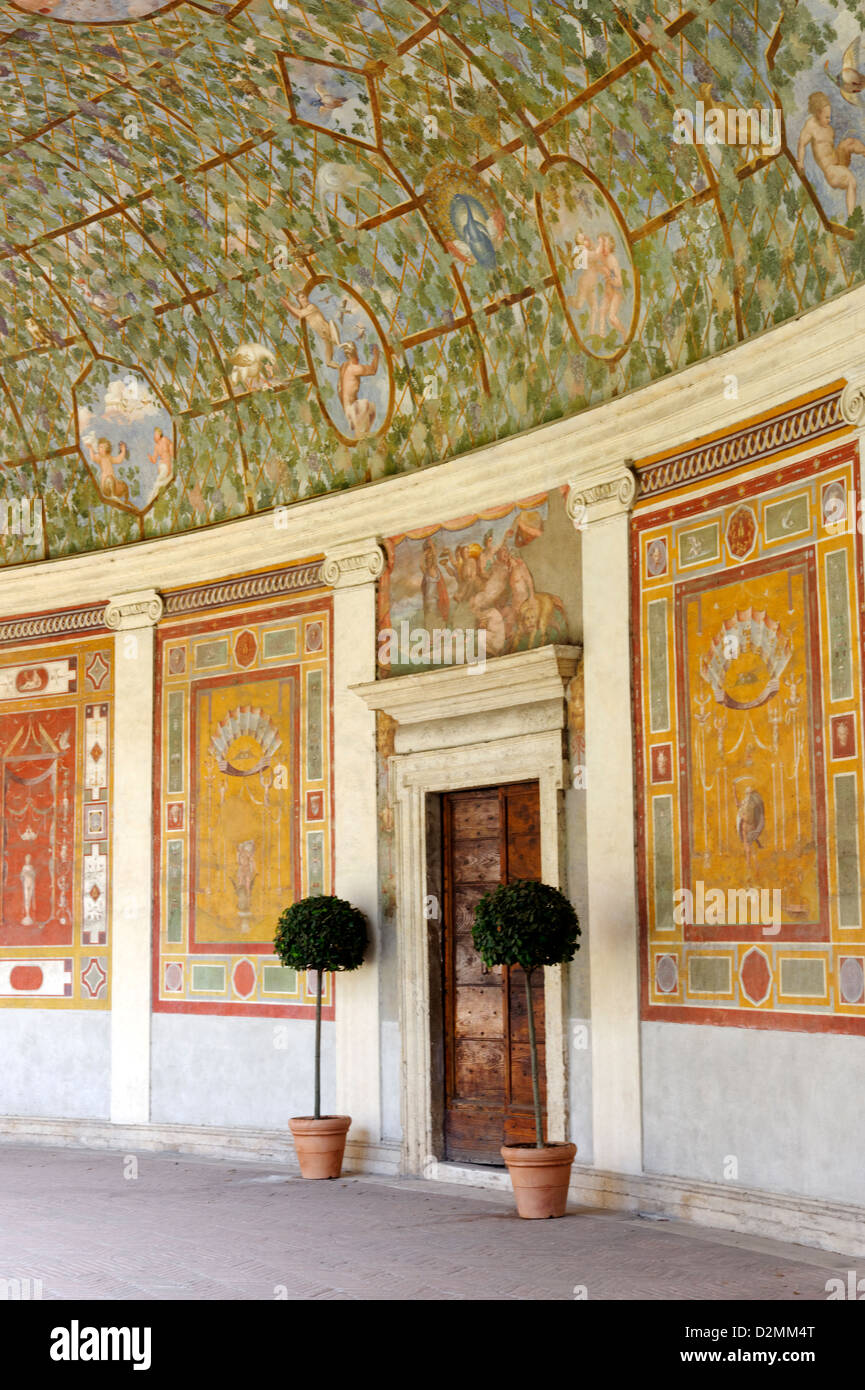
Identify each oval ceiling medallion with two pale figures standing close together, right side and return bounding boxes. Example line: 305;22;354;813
537;158;640;361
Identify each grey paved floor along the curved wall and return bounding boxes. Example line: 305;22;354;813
0;1144;851;1301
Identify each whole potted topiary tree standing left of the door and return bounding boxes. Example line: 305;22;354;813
274;897;367;1177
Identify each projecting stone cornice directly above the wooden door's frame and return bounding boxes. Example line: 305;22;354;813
350;645;583;724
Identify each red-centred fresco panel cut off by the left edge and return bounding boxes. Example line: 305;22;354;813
0;634;114;1009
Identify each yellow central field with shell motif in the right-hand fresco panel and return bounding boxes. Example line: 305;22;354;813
684;569;819;923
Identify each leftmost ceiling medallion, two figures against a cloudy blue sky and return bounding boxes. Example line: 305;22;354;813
74;360;177;512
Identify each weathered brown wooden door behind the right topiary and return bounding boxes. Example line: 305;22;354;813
442;783;545;1165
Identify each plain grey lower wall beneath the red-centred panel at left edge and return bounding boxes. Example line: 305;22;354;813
0;1009;111;1120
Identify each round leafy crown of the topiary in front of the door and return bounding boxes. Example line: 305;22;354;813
471;878;580;970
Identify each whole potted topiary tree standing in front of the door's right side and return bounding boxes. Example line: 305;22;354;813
471;878;580;1218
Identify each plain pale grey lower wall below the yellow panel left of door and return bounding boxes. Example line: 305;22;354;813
150;1013;335;1137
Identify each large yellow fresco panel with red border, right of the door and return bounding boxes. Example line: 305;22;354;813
631;434;865;1033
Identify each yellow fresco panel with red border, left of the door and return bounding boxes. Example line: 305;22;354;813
154;598;334;1017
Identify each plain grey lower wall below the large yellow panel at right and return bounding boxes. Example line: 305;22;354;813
642;1023;865;1204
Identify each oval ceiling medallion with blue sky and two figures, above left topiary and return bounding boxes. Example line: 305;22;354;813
292;279;394;443
